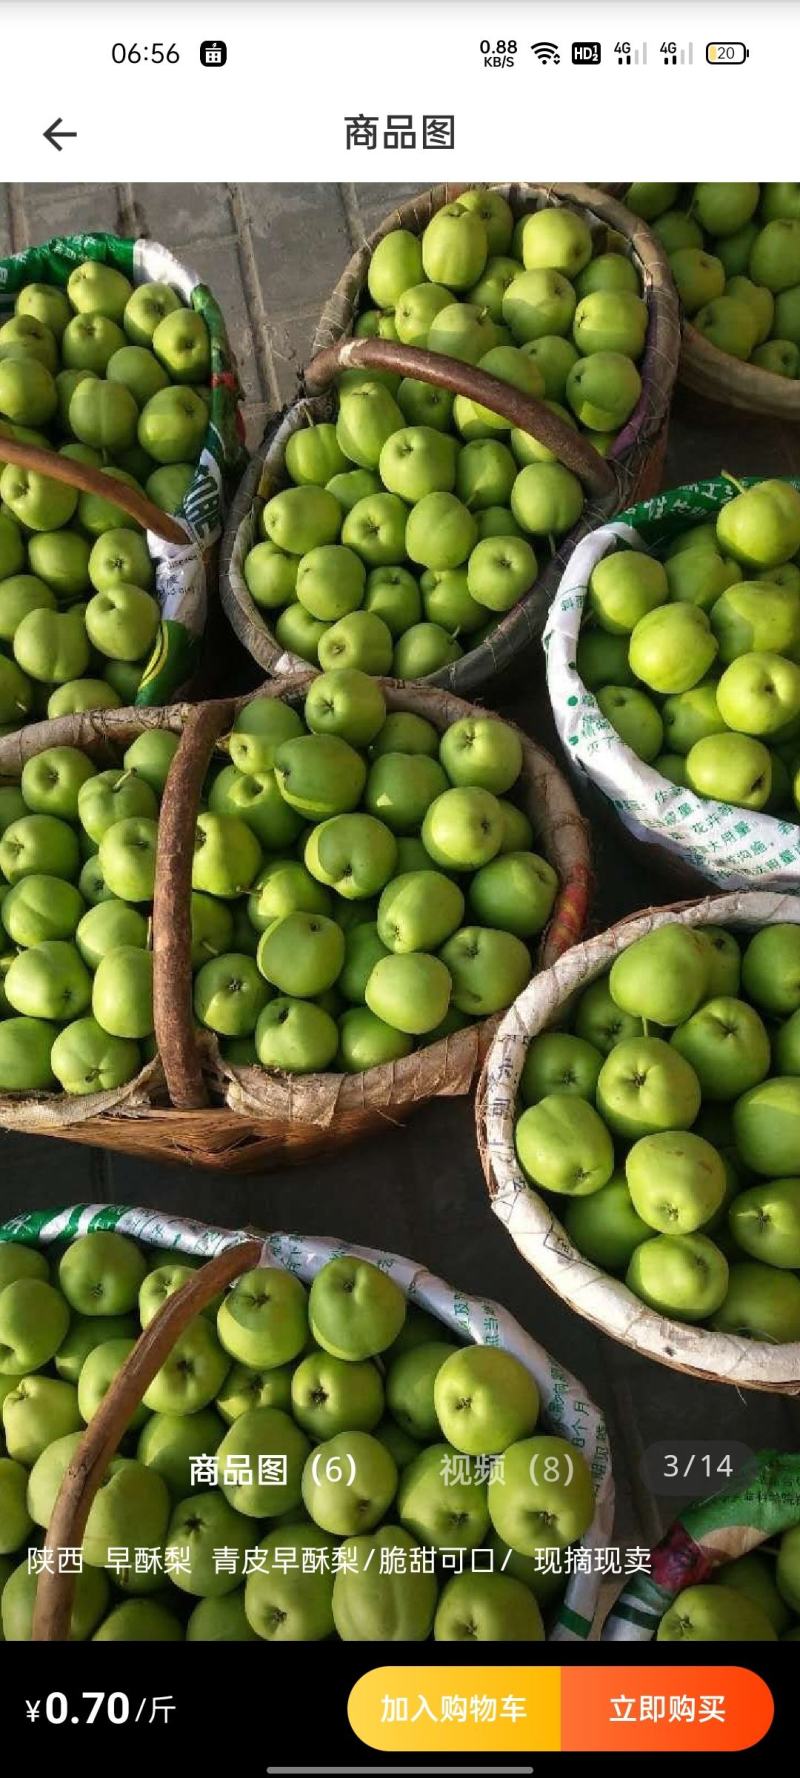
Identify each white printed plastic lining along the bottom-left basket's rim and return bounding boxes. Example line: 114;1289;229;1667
0;1204;613;1641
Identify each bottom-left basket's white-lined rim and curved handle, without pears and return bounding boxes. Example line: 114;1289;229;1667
0;1204;613;1641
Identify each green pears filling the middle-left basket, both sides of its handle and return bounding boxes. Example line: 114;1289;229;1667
0;669;558;1093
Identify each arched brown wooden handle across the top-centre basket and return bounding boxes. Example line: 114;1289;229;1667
306;338;617;500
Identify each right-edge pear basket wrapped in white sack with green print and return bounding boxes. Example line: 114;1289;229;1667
544;477;800;894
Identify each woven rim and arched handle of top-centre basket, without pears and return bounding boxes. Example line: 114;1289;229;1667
220;185;679;695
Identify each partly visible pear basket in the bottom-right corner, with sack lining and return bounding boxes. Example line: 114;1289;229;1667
603;1451;800;1643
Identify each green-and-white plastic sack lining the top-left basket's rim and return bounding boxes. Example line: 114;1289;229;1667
0;235;244;706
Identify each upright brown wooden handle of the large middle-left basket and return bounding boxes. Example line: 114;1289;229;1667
153;699;235;1111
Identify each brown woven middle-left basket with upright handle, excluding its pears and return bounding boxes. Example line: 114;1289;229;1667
0;672;592;1172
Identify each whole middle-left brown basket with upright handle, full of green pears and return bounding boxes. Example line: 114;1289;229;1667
0;669;590;1170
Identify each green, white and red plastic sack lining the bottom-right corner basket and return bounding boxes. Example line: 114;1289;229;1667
601;1451;800;1643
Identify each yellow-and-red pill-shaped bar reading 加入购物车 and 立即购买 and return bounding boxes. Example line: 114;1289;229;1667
348;1666;773;1753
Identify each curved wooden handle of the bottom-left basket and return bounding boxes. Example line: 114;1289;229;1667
32;1239;263;1643
